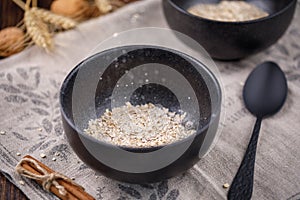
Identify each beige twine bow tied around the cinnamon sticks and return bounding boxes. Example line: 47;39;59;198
16;158;83;195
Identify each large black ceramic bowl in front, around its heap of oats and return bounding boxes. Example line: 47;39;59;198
60;46;221;183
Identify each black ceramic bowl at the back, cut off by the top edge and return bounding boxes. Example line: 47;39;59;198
162;0;297;60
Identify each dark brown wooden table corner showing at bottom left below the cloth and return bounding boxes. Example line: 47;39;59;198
0;173;28;200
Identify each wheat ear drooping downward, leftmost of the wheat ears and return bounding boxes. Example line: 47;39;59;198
24;9;53;50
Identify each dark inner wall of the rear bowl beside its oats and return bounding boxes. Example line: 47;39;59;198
169;0;294;15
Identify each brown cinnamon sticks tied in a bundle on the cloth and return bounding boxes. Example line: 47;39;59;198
17;155;95;200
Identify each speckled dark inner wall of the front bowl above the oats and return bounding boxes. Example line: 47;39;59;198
61;46;221;148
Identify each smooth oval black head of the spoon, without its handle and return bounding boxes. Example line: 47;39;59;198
243;62;287;117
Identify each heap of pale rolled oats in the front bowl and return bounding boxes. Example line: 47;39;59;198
84;102;196;147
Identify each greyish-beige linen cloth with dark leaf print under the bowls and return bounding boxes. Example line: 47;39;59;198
0;0;300;200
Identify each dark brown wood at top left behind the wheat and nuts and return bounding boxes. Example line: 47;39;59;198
0;0;52;29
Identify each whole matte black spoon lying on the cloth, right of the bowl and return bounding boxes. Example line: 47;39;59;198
228;62;288;200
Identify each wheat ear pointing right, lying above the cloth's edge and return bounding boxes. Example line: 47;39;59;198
30;7;77;29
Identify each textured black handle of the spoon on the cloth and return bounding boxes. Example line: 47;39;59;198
227;118;262;200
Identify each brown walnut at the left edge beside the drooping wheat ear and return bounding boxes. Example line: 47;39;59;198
0;27;25;57
